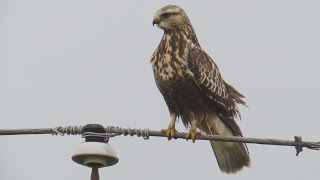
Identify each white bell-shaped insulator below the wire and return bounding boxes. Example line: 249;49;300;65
72;142;119;168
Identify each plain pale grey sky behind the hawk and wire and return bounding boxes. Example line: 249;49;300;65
0;0;320;180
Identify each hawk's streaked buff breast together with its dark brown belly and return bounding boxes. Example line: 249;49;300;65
151;34;210;115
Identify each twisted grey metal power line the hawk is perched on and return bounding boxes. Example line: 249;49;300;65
0;126;320;155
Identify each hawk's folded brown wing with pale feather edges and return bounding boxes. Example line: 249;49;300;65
187;47;245;135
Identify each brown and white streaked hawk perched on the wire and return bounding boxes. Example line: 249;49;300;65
151;5;250;173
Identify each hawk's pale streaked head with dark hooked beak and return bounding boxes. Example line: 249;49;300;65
152;5;190;31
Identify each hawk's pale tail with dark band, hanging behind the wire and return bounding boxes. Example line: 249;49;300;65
200;114;250;174
